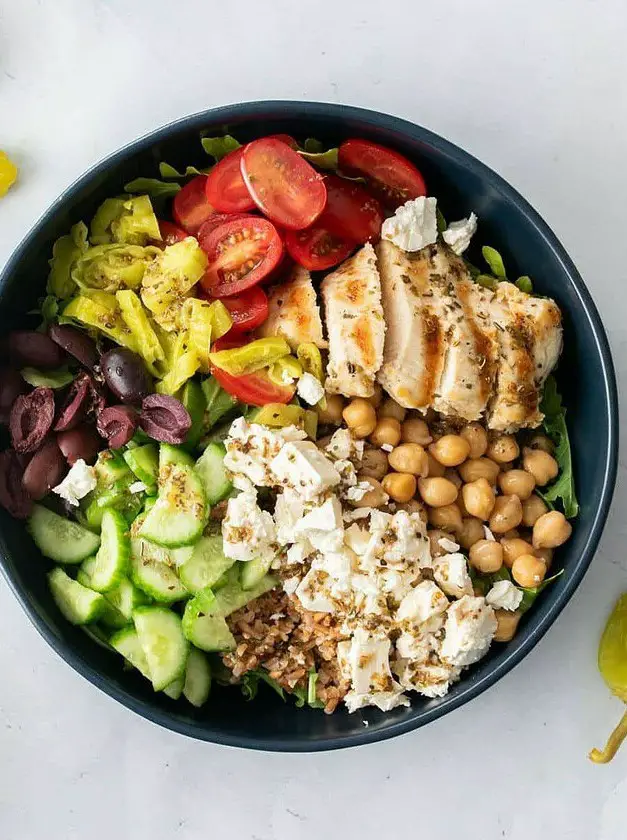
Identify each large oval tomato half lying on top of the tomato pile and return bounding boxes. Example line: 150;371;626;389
241;137;327;230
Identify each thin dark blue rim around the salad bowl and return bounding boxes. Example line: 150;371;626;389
0;100;618;753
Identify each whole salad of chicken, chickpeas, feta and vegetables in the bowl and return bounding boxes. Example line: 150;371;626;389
0;134;578;714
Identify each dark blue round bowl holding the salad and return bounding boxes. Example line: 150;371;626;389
0;102;618;751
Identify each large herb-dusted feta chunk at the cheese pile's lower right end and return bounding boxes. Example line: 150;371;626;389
440;595;496;668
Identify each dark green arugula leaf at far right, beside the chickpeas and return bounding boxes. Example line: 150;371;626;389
540;376;579;519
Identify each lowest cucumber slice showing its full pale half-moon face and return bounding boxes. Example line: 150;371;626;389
133;607;189;691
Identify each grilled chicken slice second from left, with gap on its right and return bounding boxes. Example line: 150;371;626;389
321;244;385;397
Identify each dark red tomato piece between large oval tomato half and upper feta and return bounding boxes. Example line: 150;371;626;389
318;175;385;244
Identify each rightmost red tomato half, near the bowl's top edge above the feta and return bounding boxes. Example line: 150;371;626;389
339;140;427;208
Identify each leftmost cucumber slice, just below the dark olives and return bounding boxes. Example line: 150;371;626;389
27;505;100;563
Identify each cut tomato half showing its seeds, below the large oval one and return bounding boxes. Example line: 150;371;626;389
201;216;283;297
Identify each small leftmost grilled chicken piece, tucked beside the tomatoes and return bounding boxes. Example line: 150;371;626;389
257;265;327;350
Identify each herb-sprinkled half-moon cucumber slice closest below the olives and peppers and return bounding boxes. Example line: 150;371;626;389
140;444;207;548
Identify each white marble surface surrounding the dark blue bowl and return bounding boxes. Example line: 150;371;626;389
0;0;627;840
